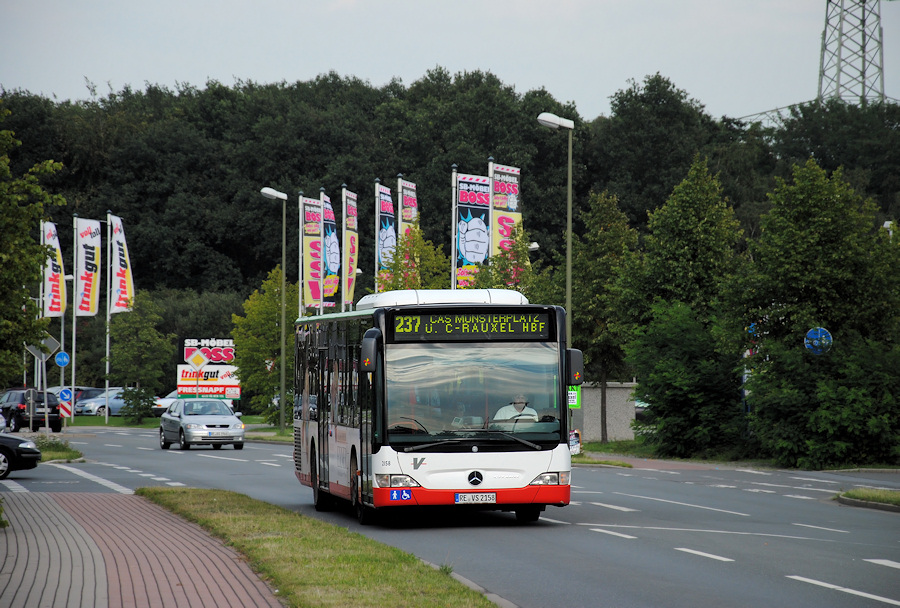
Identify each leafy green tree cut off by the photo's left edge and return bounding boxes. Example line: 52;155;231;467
0;100;65;386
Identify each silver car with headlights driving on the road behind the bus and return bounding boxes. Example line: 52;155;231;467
159;399;244;450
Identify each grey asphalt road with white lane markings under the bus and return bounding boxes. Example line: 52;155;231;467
0;429;900;608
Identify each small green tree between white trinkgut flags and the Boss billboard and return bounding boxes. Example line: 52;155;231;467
109;292;175;424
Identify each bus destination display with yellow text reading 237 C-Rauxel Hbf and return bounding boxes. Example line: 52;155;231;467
394;313;550;342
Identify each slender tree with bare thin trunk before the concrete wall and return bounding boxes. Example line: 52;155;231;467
571;192;637;442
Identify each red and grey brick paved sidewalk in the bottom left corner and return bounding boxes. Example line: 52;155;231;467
0;492;282;608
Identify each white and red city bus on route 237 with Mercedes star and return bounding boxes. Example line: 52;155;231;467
293;289;584;524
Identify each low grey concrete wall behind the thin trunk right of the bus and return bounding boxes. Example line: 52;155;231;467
572;382;635;441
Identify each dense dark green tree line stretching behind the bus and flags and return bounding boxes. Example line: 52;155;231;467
0;68;900;466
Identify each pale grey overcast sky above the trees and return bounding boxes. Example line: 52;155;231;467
0;0;900;120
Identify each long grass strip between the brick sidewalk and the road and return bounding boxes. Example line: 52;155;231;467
136;488;494;607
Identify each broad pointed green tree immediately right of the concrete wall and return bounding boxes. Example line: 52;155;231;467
620;158;741;456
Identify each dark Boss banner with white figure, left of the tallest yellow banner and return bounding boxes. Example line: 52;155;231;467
454;173;491;289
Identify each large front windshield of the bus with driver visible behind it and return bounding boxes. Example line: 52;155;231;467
385;342;565;449
